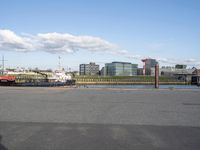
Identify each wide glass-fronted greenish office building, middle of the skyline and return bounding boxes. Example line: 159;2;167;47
104;62;138;76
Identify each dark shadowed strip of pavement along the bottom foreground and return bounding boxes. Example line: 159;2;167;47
0;122;200;150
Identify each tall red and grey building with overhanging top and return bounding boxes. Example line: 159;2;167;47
142;58;158;75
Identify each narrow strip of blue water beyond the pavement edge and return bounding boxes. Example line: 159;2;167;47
79;85;200;89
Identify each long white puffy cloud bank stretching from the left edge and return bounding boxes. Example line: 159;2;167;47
0;30;122;53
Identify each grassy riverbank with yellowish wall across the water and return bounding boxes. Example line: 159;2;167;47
74;76;191;85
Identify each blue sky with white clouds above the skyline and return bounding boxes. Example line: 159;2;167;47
0;0;200;71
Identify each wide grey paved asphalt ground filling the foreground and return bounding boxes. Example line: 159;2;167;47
0;87;200;150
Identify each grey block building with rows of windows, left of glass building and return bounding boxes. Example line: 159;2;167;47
79;62;99;75
